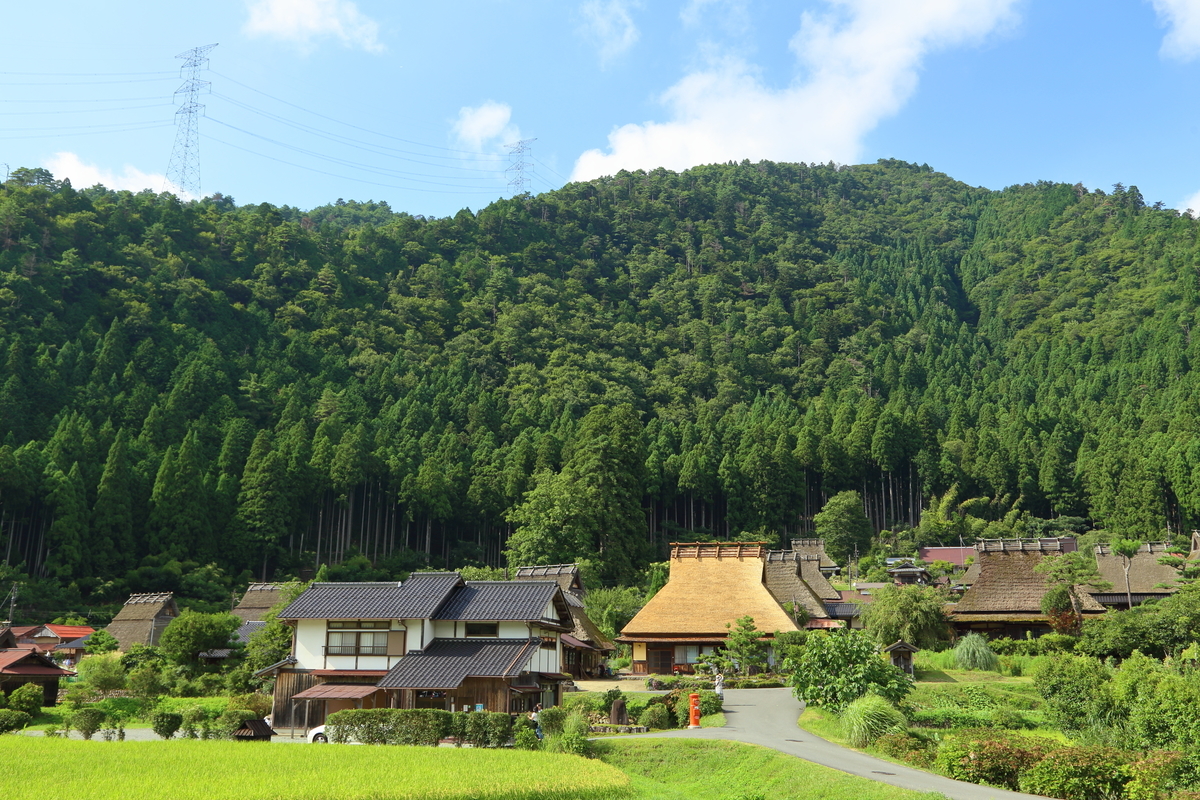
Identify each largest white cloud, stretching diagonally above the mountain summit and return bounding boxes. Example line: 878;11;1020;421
571;0;1018;180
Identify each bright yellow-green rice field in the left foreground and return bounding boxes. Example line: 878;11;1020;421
0;736;633;800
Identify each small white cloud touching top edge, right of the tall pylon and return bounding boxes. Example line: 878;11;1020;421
242;0;384;53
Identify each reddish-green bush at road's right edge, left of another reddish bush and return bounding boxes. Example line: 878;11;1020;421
935;729;1055;790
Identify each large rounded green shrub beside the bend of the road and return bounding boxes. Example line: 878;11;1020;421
785;628;912;711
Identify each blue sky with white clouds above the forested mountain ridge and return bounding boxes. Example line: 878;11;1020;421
7;0;1200;216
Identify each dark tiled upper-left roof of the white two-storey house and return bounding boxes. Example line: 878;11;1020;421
280;572;462;619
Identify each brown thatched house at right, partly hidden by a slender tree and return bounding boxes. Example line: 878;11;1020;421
947;540;1104;638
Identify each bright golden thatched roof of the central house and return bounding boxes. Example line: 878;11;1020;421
622;543;798;637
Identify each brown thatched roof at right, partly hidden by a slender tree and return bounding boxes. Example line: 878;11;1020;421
950;549;1104;619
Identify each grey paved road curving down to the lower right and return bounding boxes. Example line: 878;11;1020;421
641;688;1043;800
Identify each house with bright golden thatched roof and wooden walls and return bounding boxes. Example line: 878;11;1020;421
617;542;798;674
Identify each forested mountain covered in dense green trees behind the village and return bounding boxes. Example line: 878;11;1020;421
0;161;1200;618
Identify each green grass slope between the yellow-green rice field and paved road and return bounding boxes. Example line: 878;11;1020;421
596;739;943;800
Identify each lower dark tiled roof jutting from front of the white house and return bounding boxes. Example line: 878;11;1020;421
378;633;540;690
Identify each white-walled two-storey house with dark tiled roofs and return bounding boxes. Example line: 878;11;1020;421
259;572;574;728
